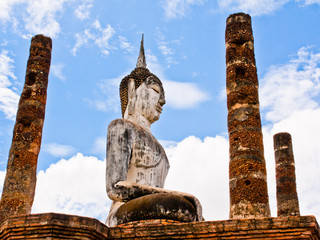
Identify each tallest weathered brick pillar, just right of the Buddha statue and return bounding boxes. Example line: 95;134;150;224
225;13;270;219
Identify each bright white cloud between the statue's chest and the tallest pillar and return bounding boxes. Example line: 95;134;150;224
165;136;229;220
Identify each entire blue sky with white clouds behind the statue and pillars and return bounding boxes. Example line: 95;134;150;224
0;0;320;221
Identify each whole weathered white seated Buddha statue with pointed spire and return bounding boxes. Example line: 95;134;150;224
106;35;203;226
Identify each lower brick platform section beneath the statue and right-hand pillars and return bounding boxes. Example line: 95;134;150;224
109;216;320;240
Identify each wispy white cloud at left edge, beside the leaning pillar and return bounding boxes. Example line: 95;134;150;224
0;50;19;120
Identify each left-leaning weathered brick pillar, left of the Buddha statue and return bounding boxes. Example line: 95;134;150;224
0;35;52;222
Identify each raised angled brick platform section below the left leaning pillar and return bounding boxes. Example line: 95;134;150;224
0;213;112;240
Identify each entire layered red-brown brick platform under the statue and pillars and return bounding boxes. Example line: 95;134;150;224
0;213;320;240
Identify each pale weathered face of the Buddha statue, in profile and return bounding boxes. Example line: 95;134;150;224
135;76;166;123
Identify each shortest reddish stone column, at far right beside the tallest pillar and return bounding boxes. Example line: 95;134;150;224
273;132;300;217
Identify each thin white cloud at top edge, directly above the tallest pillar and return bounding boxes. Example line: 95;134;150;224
218;0;290;16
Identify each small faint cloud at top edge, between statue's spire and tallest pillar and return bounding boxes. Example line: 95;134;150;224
162;0;204;19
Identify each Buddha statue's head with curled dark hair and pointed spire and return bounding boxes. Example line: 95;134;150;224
120;36;165;123
